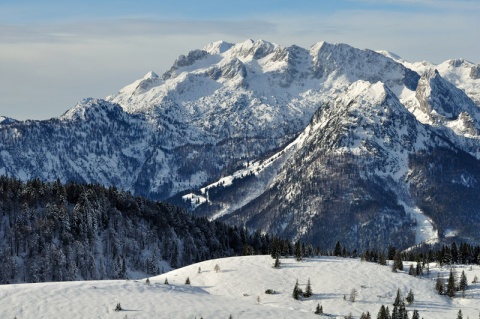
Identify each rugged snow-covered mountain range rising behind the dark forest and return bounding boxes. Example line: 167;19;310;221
0;40;480;249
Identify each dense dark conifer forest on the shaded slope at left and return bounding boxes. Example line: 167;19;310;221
0;176;271;283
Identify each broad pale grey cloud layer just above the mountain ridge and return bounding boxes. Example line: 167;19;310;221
0;0;480;119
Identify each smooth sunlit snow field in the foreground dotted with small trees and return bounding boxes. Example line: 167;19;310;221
0;256;480;319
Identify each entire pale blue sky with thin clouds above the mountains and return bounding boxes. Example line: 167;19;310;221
0;0;480;120
